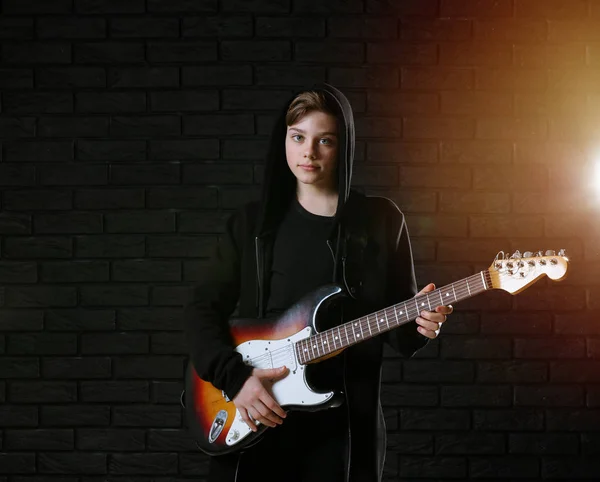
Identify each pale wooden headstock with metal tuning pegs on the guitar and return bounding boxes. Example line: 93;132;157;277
488;249;569;294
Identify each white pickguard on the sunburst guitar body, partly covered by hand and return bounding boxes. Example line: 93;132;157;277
226;327;334;445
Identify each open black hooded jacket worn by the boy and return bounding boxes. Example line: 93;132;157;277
184;84;428;482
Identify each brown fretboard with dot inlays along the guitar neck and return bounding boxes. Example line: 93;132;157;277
296;269;492;364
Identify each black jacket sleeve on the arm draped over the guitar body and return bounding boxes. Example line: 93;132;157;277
184;211;252;399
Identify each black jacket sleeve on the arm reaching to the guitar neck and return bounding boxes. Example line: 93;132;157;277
386;202;429;358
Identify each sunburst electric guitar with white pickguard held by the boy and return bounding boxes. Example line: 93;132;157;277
185;250;569;455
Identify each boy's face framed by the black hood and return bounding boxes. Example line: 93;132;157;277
285;111;338;190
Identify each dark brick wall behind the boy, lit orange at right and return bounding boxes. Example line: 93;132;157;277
0;0;600;482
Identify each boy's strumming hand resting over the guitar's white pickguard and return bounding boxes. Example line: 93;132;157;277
233;366;289;432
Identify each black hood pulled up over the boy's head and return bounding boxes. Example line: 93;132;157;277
256;84;354;240
